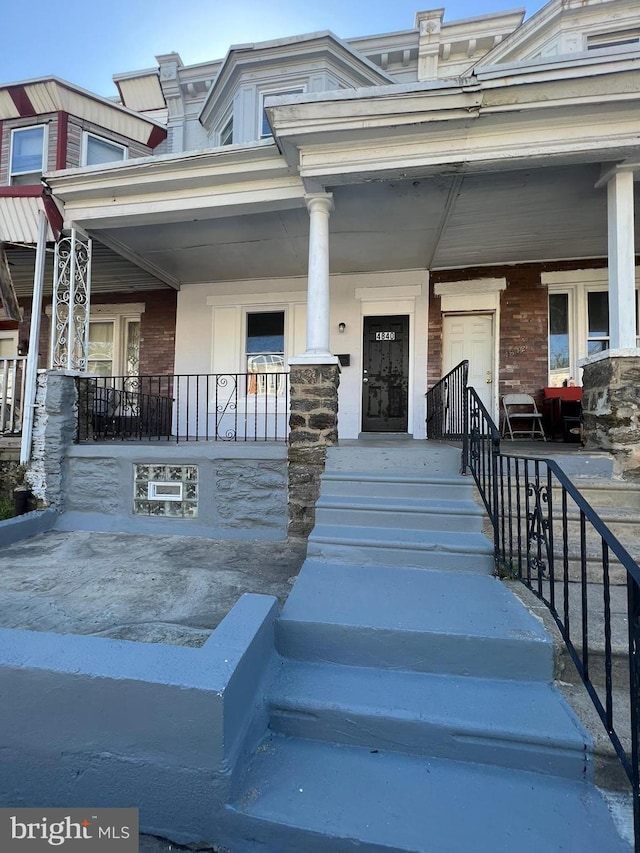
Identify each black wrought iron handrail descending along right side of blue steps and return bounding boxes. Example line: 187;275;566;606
428;363;640;853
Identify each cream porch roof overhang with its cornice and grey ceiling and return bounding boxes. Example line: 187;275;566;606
48;54;640;284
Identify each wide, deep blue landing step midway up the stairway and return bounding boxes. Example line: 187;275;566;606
276;559;553;681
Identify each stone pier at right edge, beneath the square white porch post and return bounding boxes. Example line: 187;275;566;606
582;350;640;482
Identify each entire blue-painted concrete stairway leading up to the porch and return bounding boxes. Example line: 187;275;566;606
228;442;630;853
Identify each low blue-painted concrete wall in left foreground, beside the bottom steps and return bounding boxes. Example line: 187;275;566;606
0;595;277;845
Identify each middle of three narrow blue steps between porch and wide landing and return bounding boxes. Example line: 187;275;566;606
316;495;483;532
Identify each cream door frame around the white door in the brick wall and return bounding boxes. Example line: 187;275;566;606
434;278;507;424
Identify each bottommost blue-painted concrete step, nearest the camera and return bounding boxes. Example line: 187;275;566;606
229;735;630;853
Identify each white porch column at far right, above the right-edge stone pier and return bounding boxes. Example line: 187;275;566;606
607;171;636;350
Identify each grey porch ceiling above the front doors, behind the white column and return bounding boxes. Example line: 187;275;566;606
86;163;640;284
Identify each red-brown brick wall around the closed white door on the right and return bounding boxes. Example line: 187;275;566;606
428;259;606;402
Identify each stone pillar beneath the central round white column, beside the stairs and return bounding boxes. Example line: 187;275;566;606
288;364;340;537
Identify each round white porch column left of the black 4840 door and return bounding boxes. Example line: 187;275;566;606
290;193;338;364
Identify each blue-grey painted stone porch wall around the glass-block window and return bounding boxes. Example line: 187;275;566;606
56;442;287;539
